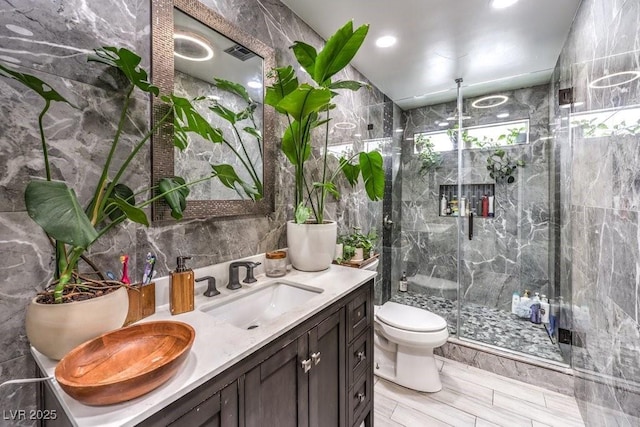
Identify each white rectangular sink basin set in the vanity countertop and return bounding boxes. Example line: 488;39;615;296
200;280;323;329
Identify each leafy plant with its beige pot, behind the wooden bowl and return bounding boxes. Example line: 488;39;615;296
0;47;235;359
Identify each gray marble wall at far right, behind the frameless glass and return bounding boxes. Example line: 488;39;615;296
551;0;640;426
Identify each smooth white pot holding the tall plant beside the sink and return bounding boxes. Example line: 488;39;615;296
287;221;338;271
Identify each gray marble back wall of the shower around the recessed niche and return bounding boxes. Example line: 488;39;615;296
399;85;551;310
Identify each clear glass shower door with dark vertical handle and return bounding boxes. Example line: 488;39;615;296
458;85;564;363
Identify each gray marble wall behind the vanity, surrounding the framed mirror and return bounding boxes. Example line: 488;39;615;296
0;0;384;416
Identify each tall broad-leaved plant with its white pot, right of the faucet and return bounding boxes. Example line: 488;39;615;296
265;21;384;271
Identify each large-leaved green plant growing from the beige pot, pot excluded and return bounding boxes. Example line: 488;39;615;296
0;47;232;303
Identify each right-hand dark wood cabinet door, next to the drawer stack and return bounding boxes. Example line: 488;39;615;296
308;309;347;427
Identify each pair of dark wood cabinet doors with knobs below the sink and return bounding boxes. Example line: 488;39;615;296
244;310;346;427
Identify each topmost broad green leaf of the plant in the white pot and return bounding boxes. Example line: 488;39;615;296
312;21;369;85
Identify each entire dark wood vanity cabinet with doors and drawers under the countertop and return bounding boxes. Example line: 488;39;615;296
37;281;373;427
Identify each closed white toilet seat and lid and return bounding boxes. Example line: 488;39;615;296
375;301;447;332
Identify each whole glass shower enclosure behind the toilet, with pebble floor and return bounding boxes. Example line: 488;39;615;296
390;78;571;365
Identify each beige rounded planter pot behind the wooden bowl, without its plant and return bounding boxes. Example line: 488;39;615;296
26;287;129;360
